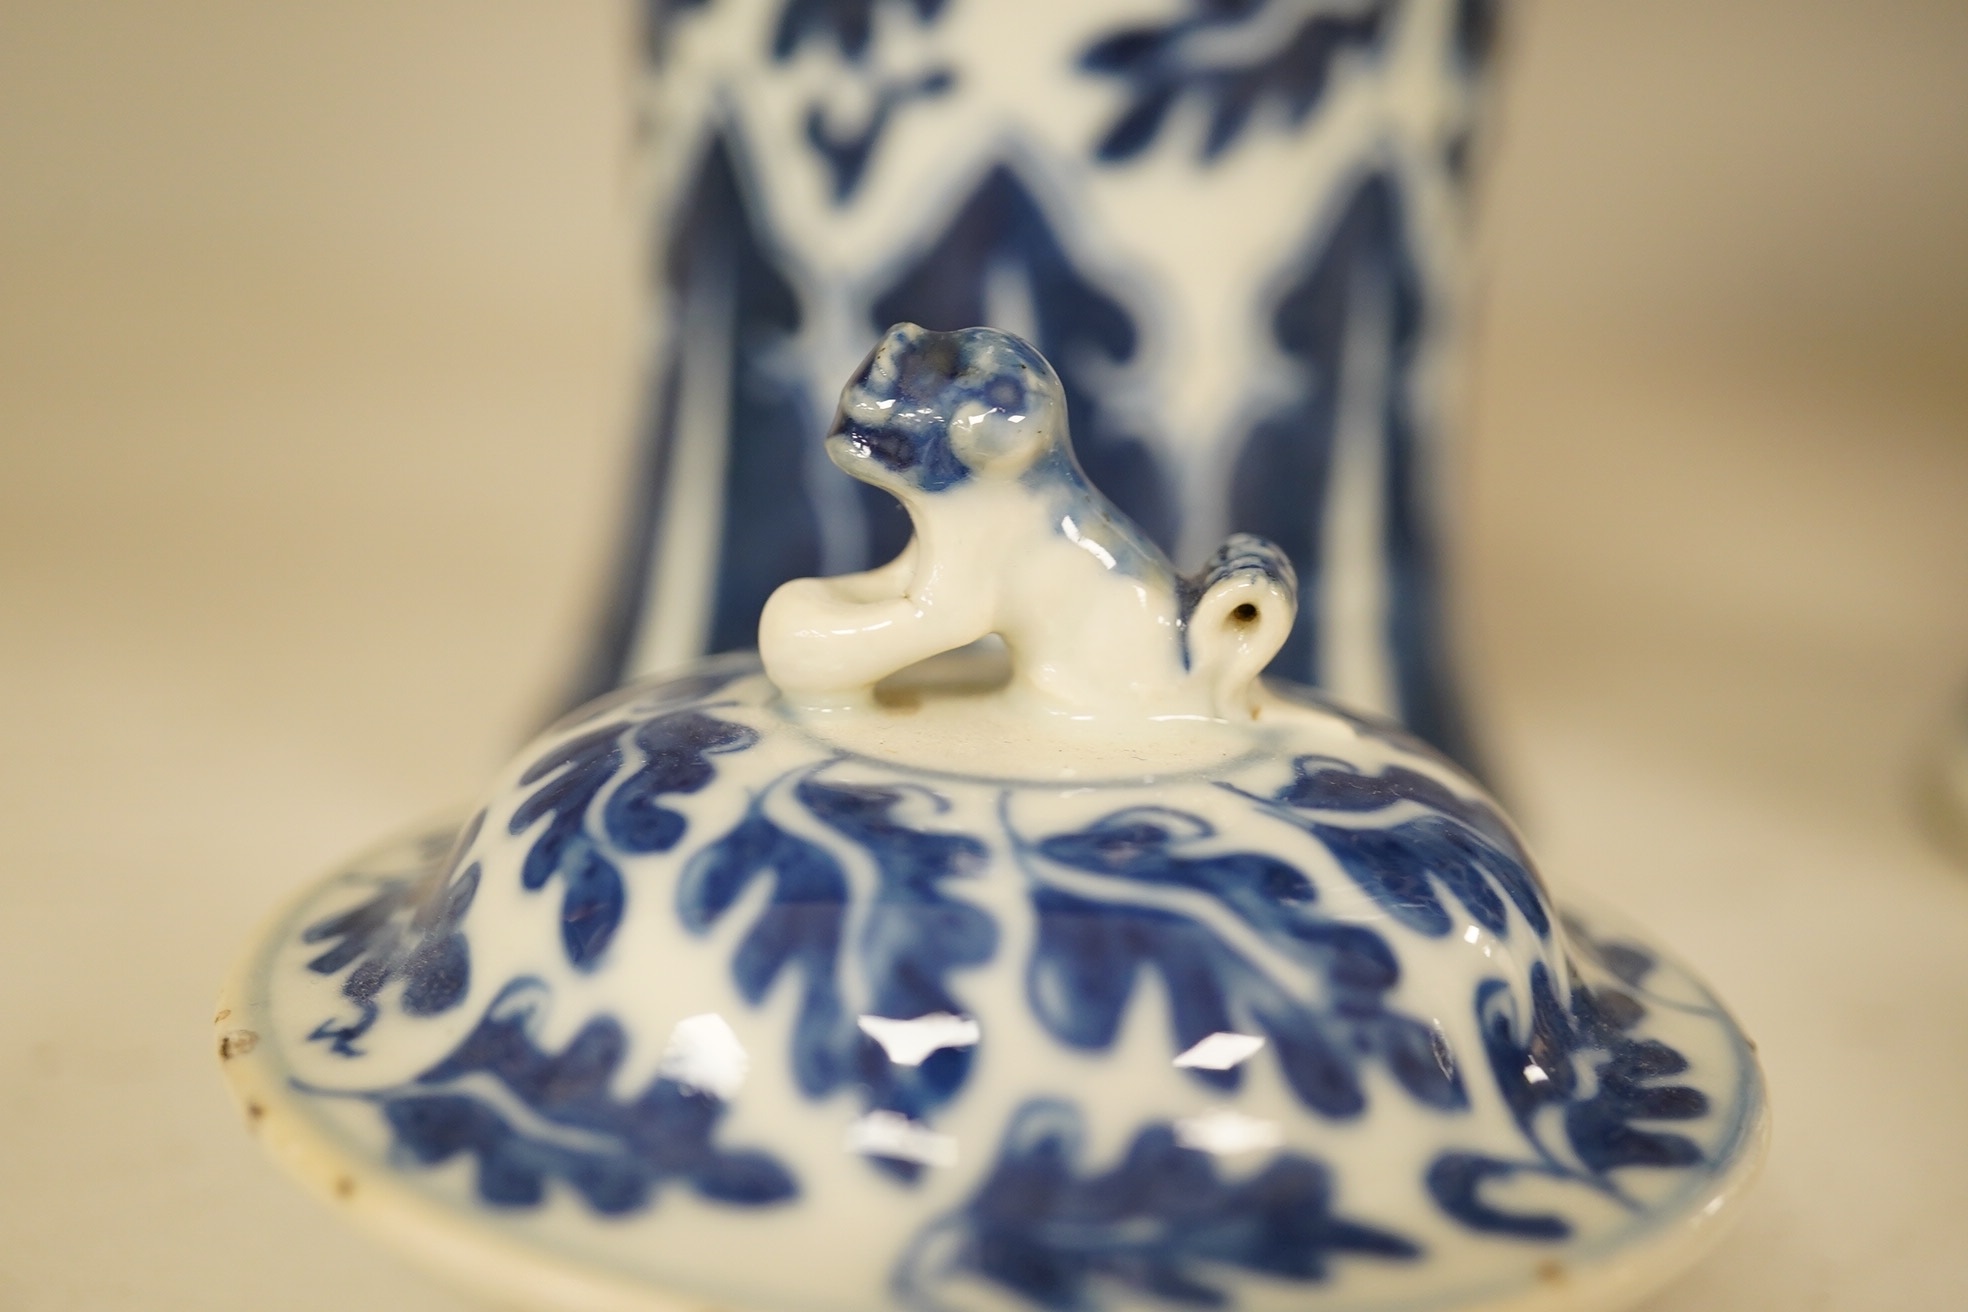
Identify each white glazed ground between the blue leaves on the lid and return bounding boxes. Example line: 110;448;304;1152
216;675;1765;1308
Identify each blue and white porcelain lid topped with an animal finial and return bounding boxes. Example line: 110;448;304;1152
218;325;1765;1312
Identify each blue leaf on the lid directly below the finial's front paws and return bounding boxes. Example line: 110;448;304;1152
677;773;998;1178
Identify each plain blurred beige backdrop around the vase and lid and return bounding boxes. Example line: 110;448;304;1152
0;0;1968;1312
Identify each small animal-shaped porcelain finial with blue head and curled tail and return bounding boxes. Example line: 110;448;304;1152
758;325;1297;720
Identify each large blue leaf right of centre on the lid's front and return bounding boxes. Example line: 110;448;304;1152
1006;806;1468;1117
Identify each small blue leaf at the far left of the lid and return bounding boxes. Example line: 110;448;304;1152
301;812;484;1056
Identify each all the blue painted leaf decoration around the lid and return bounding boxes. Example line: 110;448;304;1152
301;712;1708;1251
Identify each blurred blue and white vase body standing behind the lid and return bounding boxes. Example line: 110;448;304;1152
577;0;1492;761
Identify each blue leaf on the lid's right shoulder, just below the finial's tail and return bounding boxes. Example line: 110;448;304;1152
1244;755;1551;938
